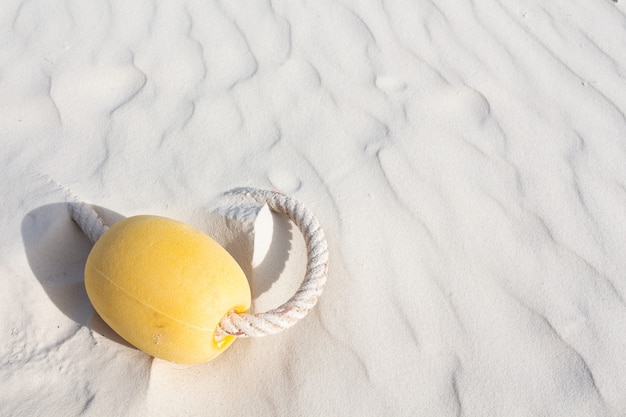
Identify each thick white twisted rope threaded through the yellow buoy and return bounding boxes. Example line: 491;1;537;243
68;188;328;339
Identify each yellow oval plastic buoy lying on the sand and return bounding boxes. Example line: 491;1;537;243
85;216;251;364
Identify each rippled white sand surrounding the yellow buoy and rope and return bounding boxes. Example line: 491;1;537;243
0;0;626;416
